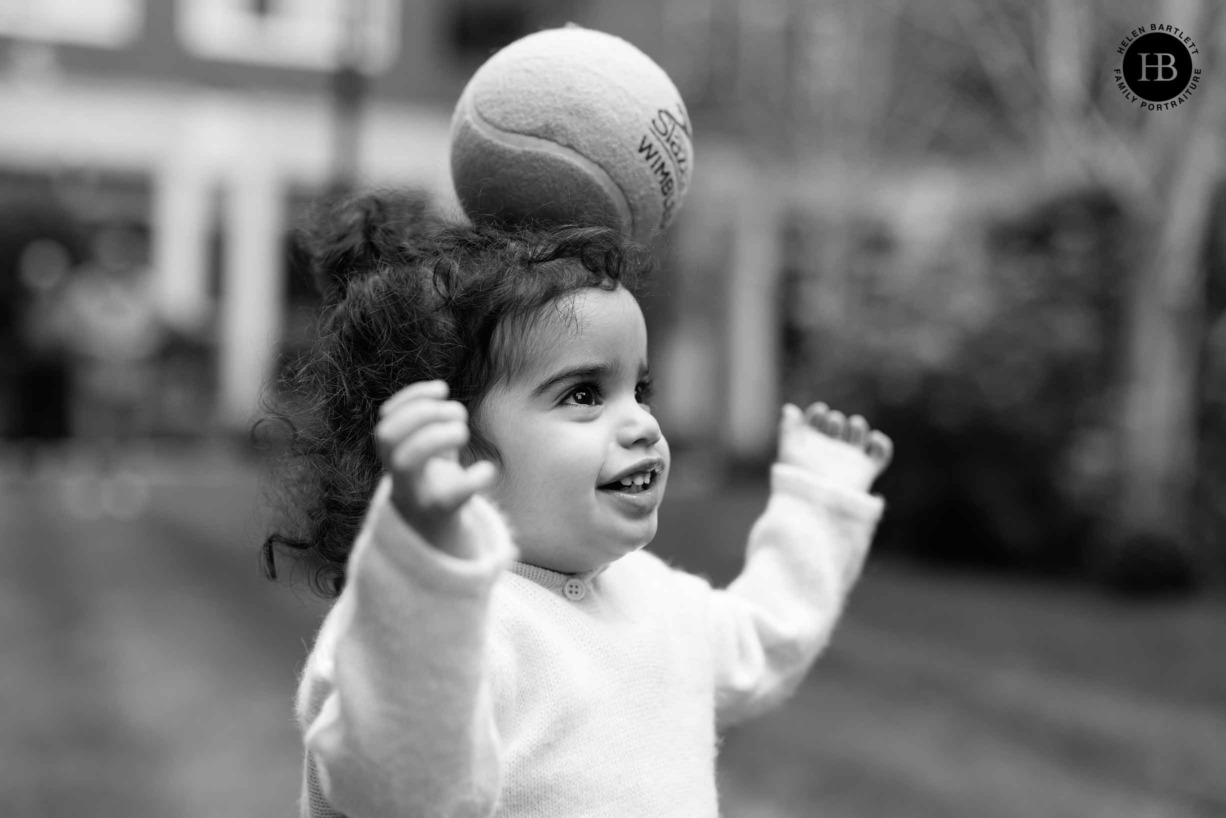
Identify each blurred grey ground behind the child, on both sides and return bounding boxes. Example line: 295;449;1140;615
0;449;1226;818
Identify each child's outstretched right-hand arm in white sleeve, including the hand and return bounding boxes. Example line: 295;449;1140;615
711;403;893;726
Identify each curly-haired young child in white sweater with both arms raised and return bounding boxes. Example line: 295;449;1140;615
266;197;891;818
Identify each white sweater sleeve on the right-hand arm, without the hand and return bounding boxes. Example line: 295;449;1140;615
710;464;884;727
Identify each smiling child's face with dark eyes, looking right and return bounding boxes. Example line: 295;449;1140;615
479;288;669;573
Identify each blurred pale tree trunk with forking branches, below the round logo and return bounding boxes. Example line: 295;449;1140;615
951;0;1226;581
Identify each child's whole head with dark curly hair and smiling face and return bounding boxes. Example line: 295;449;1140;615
257;195;667;595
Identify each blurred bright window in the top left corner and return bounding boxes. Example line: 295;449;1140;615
0;0;145;48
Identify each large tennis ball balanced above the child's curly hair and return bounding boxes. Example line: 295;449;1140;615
451;25;694;242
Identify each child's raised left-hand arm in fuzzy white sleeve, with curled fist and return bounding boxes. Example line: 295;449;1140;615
299;381;514;818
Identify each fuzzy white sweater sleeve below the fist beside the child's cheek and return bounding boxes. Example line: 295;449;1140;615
298;478;515;818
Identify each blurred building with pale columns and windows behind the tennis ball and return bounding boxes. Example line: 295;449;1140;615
0;0;837;456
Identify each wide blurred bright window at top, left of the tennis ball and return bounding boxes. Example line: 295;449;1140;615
178;0;401;74
